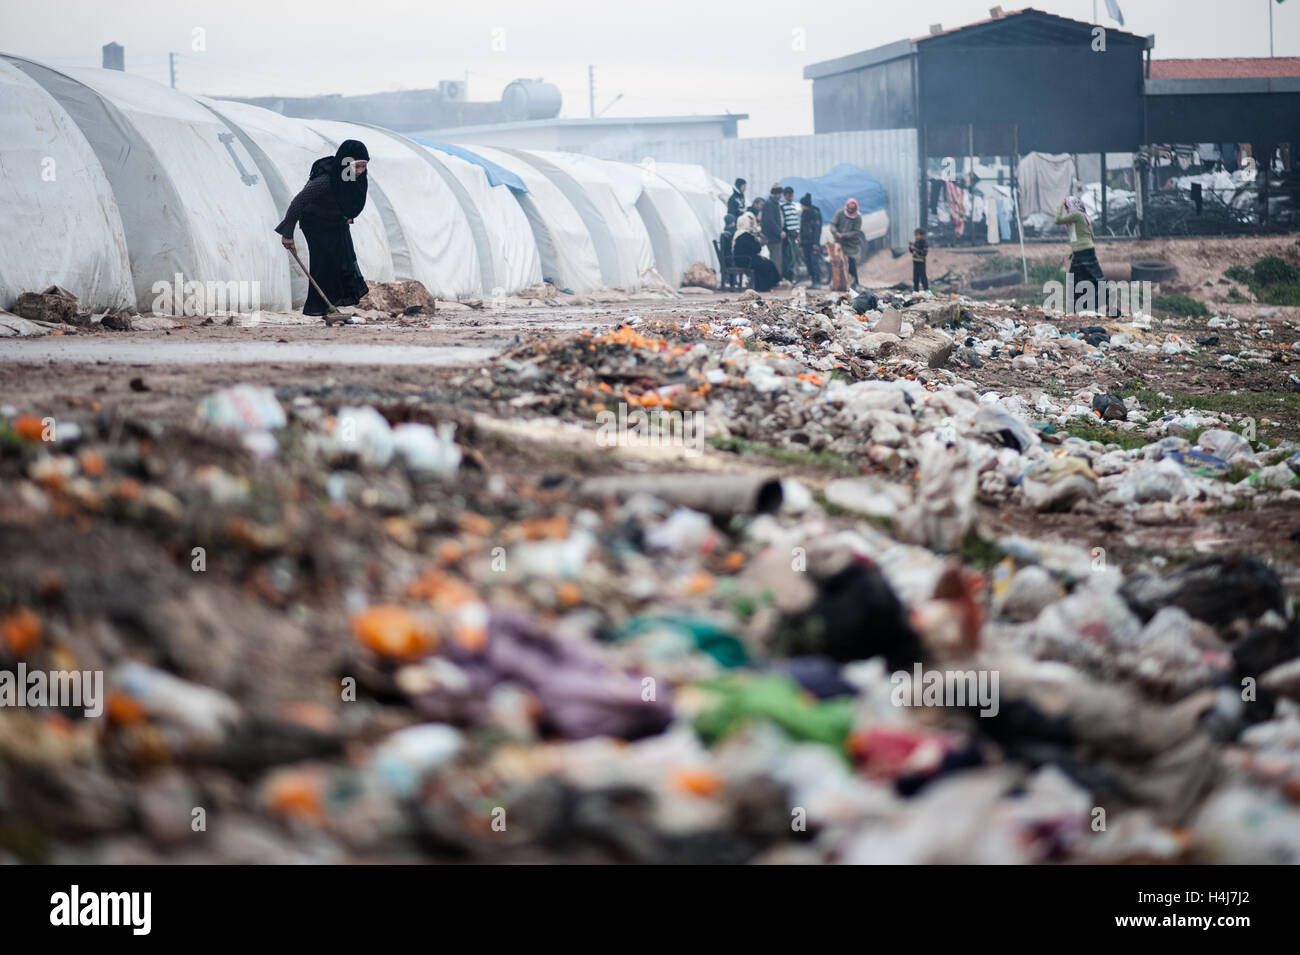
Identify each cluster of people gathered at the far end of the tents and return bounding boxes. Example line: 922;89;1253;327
719;179;866;291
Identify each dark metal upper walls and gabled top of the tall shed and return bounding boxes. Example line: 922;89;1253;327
803;8;1152;155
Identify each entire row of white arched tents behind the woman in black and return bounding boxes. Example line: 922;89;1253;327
0;55;731;311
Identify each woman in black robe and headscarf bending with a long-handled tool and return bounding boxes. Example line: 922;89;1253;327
276;139;371;316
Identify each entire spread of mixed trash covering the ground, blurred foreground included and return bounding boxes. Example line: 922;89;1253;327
0;294;1300;863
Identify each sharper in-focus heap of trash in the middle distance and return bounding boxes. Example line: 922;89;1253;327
465;294;1300;522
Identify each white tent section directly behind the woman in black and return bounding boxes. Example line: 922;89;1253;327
198;96;394;308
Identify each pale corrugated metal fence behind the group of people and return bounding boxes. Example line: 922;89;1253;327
585;129;920;248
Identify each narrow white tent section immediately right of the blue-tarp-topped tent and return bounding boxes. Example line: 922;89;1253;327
475;146;603;294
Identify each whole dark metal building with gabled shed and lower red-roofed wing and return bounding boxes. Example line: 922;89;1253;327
803;6;1300;239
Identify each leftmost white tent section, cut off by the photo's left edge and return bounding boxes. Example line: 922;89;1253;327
0;58;135;309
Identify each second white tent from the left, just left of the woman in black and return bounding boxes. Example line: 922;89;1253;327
10;57;290;311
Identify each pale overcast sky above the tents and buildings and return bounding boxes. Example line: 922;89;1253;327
0;0;1300;136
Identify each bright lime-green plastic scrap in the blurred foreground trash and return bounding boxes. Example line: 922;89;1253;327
694;674;854;754
